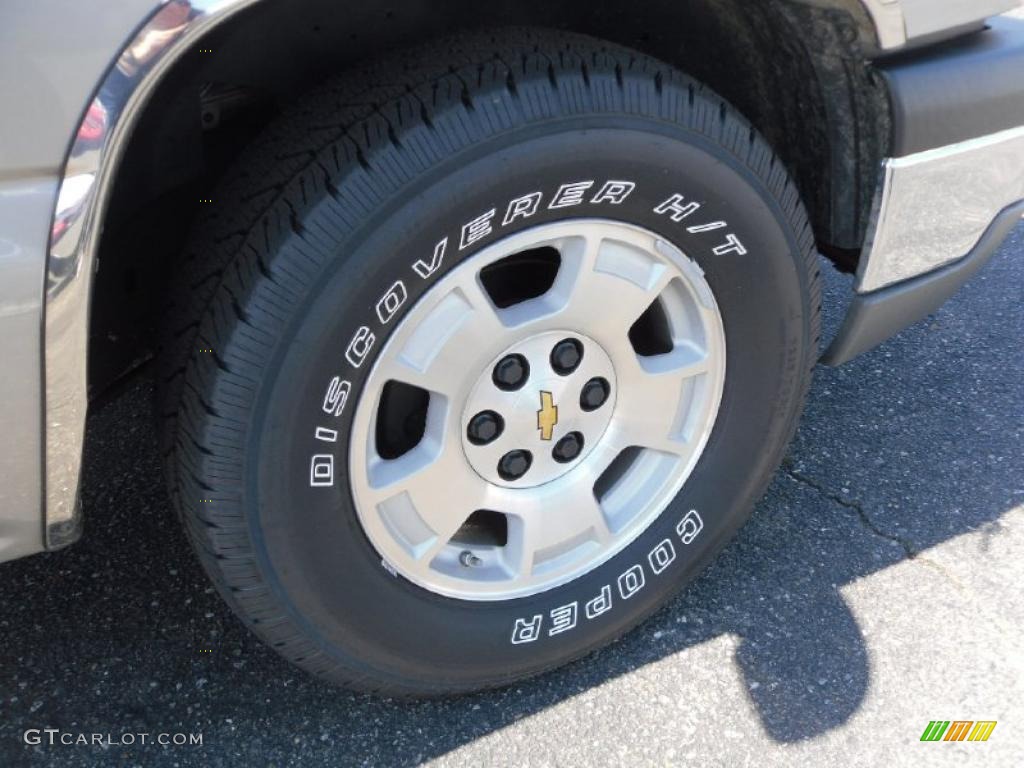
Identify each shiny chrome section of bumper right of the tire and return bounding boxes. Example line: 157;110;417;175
856;126;1024;293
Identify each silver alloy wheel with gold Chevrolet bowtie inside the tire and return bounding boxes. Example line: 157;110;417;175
349;219;725;600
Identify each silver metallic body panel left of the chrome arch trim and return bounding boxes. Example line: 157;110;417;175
0;0;156;561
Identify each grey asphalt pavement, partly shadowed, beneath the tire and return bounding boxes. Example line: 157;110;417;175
0;226;1024;767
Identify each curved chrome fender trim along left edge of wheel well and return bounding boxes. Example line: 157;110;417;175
43;0;257;549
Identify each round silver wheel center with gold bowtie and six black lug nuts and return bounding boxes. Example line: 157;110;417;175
462;331;615;488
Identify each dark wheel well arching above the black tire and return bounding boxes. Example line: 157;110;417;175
89;0;888;391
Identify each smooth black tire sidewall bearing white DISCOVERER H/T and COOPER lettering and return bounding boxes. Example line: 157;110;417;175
243;117;813;689
